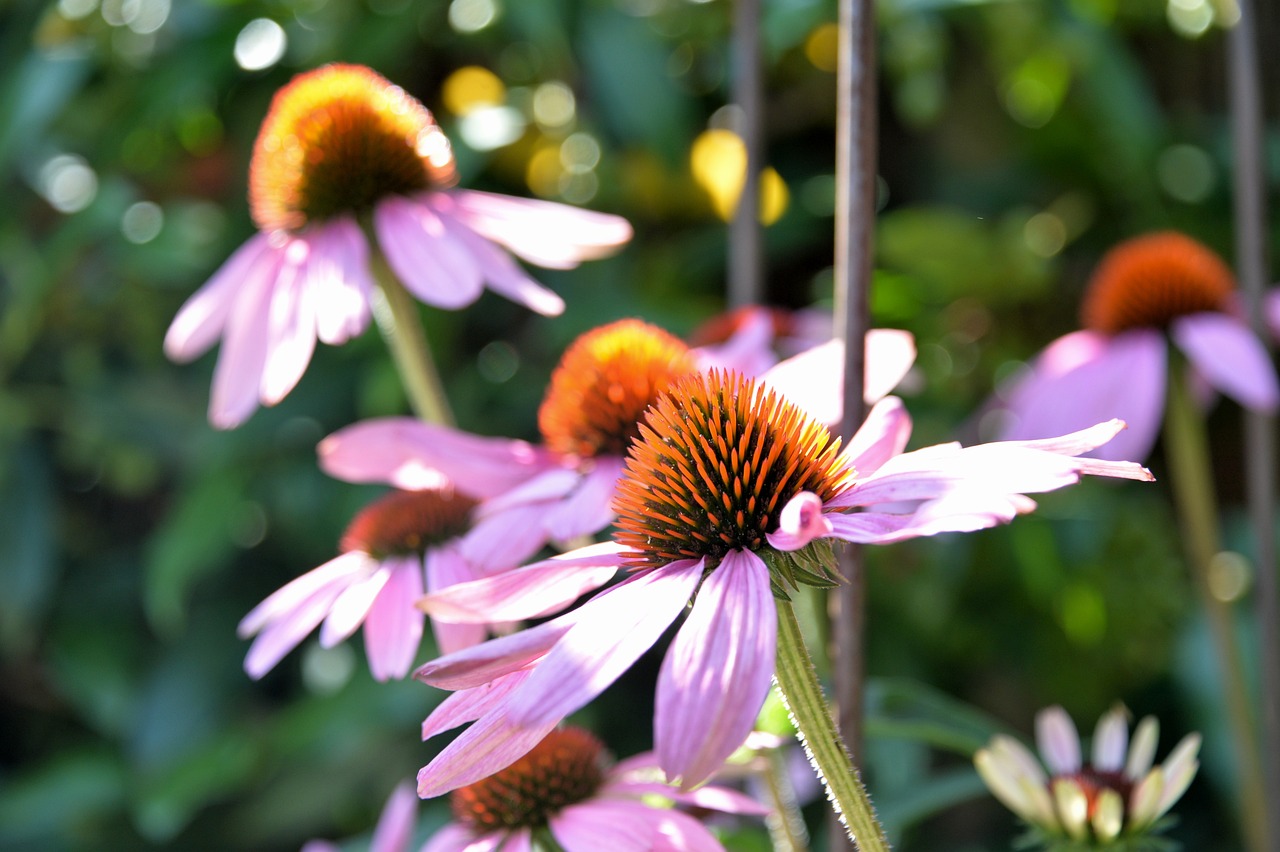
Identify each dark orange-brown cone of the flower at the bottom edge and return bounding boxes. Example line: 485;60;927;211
449;728;608;832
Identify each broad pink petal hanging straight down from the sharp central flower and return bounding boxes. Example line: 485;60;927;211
653;550;778;789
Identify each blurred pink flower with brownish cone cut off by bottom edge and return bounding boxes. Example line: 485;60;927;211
424;728;768;852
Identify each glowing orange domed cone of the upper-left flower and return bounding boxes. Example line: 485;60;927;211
248;65;457;232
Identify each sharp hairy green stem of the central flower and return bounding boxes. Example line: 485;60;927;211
774;600;890;852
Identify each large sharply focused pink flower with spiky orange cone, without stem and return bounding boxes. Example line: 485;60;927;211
415;371;1151;797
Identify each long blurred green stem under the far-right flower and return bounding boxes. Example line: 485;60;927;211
1165;357;1266;851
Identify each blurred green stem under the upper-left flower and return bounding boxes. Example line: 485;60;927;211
370;249;454;426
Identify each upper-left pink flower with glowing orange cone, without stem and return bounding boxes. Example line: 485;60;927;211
165;64;631;429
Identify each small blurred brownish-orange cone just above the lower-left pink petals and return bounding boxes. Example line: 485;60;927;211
339;489;476;558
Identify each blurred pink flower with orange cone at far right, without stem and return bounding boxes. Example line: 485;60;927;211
1001;232;1280;459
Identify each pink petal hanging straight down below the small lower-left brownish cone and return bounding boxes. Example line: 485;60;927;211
365;555;425;681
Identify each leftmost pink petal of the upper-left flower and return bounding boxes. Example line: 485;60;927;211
164;233;278;362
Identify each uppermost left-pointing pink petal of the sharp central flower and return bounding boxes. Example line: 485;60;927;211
419;541;631;624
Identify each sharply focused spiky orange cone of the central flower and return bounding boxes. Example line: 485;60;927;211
613;370;851;568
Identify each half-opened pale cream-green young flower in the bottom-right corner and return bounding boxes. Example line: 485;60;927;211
973;706;1201;846
